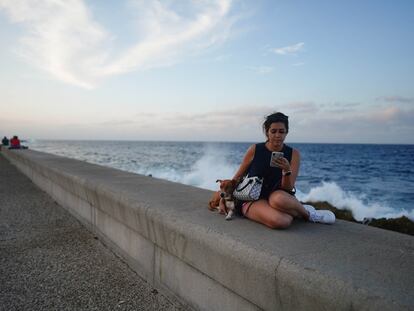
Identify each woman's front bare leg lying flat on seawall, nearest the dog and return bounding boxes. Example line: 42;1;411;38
242;200;293;229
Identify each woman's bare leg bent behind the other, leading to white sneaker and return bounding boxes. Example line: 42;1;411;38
269;190;309;220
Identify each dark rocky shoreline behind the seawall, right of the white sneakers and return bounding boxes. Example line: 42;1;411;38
304;201;414;235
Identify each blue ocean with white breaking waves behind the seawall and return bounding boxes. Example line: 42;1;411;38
25;140;414;220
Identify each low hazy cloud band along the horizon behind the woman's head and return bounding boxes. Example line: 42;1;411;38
85;104;414;143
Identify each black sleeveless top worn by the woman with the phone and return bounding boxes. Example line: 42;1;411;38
247;143;293;199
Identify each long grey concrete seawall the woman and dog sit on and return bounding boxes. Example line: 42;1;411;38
2;149;414;310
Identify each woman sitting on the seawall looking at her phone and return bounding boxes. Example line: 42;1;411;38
233;112;335;229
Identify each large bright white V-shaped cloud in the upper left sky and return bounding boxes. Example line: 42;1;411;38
0;0;235;88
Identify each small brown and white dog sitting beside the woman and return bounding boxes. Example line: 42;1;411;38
208;179;237;220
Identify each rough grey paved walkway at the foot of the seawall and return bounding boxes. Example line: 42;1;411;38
0;154;185;311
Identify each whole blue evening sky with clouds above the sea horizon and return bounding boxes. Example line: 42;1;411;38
0;0;414;144
